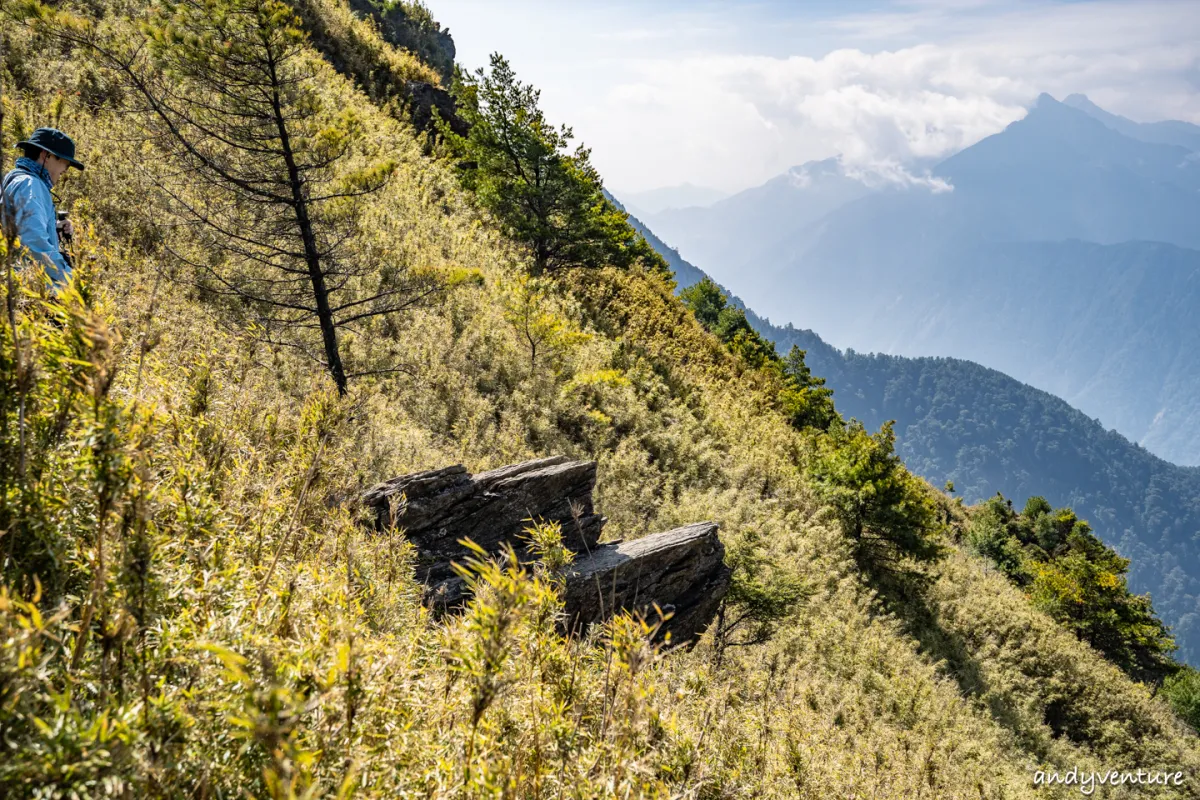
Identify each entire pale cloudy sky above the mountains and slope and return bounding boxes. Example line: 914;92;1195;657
428;0;1200;192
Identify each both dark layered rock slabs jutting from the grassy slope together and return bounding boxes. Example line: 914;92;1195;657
362;456;730;642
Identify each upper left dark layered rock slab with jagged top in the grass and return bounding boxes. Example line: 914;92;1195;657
364;456;604;606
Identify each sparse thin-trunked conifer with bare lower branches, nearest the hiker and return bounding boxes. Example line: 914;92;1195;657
22;0;432;393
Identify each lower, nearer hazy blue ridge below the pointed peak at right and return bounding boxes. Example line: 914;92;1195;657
751;239;1200;464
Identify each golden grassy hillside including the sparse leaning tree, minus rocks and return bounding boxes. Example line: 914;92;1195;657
0;0;1200;798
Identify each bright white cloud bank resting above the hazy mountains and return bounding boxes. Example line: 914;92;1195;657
605;46;1037;190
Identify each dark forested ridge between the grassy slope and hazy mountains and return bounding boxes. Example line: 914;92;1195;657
630;206;1200;666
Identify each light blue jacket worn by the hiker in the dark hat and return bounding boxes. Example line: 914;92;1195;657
2;157;71;287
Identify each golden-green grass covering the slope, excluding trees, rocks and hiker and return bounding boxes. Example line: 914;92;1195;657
0;0;1200;798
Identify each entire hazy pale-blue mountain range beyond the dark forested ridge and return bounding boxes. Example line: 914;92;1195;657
628;95;1200;464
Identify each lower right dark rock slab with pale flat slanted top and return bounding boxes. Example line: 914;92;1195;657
564;522;730;640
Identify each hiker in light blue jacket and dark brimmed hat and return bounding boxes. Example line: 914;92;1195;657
0;128;83;289
